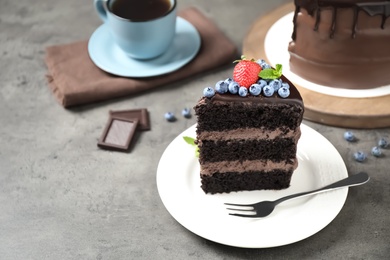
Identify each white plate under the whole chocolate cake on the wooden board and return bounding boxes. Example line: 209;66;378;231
264;13;390;98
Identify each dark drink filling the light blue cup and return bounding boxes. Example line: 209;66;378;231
109;0;172;21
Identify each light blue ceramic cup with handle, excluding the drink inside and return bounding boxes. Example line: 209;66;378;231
94;0;176;60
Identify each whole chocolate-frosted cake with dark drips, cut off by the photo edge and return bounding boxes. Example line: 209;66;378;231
288;0;390;89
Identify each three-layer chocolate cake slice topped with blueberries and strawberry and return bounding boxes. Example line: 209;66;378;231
194;57;304;194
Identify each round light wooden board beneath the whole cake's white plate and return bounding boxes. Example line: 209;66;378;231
242;3;390;129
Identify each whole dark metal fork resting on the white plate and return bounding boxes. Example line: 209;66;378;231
225;172;370;218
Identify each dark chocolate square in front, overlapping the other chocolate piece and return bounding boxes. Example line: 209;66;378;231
98;115;138;151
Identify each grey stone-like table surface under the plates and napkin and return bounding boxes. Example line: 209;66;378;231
0;0;390;259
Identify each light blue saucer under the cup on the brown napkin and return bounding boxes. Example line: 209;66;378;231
88;17;201;78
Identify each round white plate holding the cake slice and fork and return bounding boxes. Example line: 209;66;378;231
157;124;348;248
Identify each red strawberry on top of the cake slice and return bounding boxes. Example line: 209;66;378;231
233;56;261;88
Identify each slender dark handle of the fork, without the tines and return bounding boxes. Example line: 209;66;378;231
275;172;370;204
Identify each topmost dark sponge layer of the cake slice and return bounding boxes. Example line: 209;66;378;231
195;95;303;131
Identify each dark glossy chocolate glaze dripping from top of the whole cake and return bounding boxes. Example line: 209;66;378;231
291;0;390;41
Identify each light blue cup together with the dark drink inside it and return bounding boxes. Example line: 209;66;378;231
94;0;177;60
